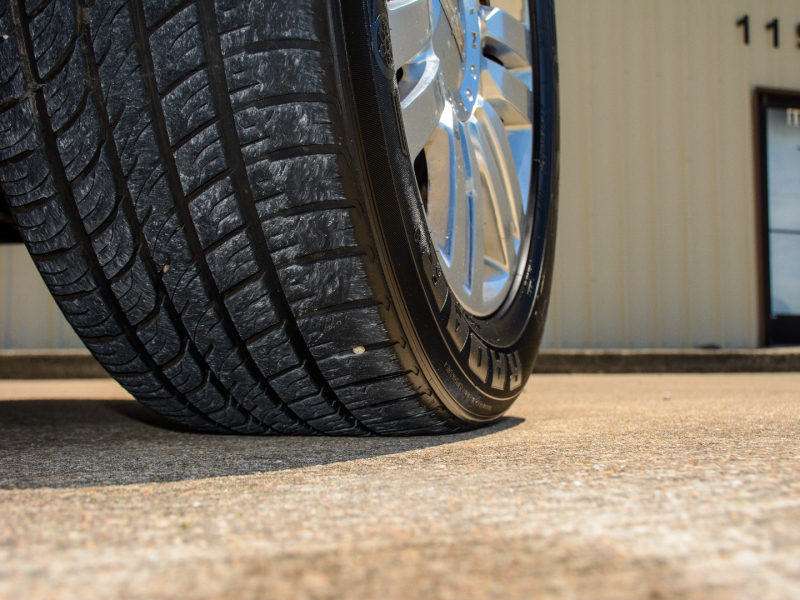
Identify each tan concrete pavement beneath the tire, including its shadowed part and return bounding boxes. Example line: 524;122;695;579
0;374;800;599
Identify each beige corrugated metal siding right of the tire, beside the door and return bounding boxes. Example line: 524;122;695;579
544;0;800;348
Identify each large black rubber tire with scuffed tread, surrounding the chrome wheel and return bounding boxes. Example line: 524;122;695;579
0;0;556;435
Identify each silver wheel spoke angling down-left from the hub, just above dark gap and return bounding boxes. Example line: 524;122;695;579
400;57;445;160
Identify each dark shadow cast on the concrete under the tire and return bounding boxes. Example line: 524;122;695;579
0;400;524;489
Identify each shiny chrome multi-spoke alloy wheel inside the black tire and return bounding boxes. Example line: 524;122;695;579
388;0;533;317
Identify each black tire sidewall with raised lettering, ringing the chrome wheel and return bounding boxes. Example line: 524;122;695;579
342;0;558;421
